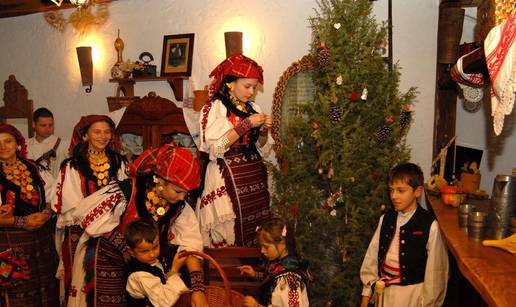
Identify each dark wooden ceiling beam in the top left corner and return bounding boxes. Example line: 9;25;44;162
0;0;115;18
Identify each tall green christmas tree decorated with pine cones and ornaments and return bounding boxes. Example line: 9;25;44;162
273;0;415;306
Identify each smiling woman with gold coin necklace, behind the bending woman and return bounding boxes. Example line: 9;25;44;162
54;115;127;306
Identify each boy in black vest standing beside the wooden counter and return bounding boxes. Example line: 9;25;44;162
360;163;448;307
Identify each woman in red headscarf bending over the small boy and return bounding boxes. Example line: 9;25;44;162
68;144;207;307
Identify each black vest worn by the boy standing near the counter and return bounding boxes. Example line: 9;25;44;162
378;205;435;285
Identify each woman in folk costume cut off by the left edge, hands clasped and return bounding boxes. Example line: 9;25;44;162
0;124;59;307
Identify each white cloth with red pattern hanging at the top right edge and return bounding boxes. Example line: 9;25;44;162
484;13;516;135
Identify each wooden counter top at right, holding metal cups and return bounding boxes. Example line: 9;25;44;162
428;195;516;307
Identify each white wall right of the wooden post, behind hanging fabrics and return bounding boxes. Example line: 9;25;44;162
456;9;516;194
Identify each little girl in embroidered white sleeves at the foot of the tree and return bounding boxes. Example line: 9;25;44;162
238;218;309;307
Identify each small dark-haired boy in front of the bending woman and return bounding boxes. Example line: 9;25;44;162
125;219;188;307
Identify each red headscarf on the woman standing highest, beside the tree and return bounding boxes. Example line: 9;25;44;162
210;54;263;97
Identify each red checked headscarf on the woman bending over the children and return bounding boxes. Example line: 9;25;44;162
129;144;201;191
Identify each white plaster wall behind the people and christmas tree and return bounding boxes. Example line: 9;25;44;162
0;0;439;175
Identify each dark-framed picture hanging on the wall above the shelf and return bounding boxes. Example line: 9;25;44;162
161;33;194;76
